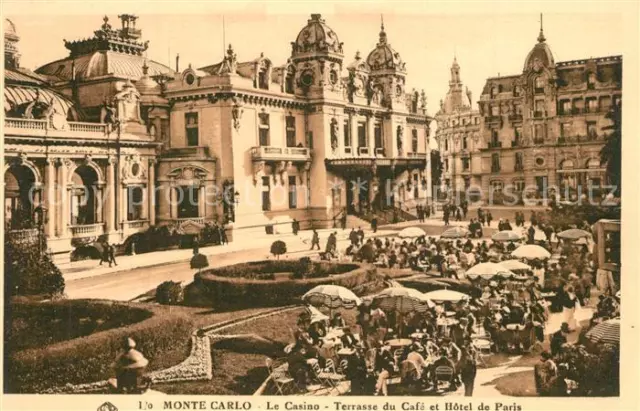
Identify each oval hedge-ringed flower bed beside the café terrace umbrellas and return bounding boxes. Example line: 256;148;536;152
185;261;375;308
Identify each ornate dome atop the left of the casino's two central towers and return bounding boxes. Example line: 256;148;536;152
291;14;342;55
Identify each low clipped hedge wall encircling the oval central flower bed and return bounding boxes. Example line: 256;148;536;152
191;261;376;308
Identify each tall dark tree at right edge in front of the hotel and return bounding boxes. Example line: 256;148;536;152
600;102;622;196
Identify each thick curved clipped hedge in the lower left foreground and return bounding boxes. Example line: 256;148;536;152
4;300;193;393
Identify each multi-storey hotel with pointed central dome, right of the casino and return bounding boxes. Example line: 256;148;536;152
439;19;622;203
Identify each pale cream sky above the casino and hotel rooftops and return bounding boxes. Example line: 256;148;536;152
4;1;637;121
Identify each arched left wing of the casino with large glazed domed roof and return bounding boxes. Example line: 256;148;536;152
4;15;172;261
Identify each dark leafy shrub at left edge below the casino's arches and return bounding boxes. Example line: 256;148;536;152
4;237;65;296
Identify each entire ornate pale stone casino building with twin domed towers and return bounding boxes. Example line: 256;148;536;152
4;14;430;259
